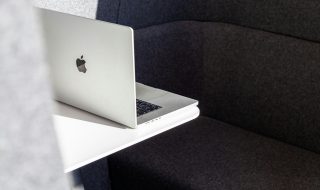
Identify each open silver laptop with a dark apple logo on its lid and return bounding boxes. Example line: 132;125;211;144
37;8;199;128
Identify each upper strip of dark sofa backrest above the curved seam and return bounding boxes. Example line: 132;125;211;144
97;0;320;41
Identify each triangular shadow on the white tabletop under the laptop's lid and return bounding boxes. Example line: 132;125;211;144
53;101;128;129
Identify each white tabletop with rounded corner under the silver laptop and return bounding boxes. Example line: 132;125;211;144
53;102;199;173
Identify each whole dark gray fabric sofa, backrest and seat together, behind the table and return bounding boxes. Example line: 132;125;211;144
81;0;320;190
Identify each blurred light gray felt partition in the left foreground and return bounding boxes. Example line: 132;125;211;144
0;0;68;190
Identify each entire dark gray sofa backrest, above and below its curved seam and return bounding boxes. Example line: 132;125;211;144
97;0;320;153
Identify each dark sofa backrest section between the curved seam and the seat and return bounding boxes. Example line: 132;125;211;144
135;21;320;152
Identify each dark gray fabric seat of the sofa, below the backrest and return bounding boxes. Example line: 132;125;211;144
108;117;320;190
